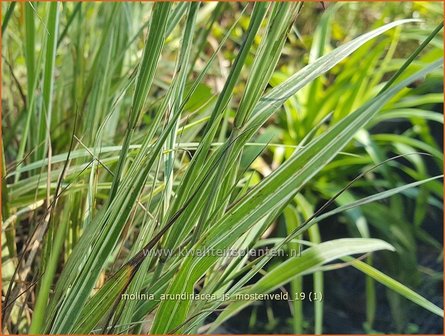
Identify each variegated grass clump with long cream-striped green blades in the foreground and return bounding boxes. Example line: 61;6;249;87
2;2;443;334
